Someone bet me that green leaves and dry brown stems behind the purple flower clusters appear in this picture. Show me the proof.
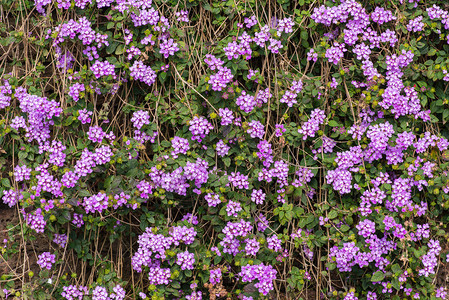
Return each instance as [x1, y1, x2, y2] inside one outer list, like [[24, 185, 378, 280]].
[[0, 0, 449, 299]]
